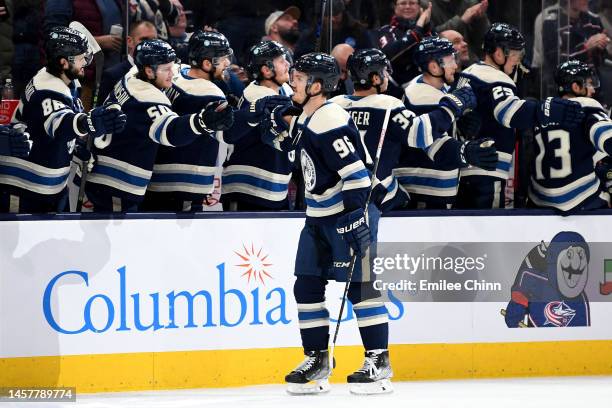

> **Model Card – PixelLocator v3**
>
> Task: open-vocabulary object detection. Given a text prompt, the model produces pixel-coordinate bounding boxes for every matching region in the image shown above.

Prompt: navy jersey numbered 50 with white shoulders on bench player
[86,71,210,203]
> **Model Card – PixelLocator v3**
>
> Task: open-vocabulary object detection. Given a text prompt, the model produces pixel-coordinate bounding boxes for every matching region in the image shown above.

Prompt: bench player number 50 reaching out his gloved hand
[85,40,233,212]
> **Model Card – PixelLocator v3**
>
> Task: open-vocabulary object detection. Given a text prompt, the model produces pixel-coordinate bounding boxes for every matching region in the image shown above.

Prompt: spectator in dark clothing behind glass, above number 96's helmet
[295,0,374,59]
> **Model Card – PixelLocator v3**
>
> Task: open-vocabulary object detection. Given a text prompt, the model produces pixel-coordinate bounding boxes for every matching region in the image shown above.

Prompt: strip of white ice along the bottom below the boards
[11,377,612,408]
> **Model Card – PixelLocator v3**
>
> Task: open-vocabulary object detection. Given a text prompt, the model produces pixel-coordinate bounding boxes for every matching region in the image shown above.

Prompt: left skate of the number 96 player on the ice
[285,350,331,395]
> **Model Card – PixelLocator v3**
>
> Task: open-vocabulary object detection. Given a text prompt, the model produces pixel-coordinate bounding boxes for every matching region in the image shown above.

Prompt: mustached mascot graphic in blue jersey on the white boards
[502,231,591,327]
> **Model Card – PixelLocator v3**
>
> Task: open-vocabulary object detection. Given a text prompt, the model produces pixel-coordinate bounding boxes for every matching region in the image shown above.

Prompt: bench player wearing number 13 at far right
[529,60,612,212]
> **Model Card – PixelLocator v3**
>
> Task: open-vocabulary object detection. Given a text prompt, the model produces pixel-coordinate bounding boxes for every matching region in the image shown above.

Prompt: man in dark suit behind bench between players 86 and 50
[99,20,157,101]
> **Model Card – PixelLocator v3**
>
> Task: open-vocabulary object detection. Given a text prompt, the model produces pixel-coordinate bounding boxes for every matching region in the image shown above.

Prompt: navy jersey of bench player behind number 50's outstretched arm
[148,65,225,201]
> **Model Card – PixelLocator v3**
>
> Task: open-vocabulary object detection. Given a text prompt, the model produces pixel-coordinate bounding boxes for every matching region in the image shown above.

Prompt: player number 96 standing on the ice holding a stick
[262,53,392,394]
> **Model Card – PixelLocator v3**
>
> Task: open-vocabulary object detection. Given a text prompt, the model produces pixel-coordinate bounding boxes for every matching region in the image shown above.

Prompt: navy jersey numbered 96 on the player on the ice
[289,102,370,224]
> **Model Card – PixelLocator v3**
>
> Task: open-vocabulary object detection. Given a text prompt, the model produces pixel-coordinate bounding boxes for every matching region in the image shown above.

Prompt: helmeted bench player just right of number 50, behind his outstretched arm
[143,31,232,212]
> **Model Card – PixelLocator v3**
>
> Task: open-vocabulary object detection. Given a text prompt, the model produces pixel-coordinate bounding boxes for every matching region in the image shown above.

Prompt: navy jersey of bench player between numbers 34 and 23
[402,75,459,204]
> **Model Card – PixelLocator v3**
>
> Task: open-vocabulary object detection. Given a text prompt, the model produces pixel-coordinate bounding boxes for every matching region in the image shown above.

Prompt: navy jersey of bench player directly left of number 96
[221,82,295,209]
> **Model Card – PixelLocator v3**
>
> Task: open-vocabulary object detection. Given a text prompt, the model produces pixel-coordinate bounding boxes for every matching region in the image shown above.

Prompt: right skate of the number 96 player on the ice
[347,350,393,395]
